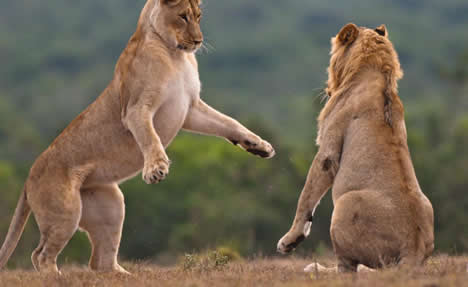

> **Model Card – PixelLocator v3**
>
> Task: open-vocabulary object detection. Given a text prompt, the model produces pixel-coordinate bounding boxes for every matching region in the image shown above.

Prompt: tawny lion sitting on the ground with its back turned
[277,24,434,272]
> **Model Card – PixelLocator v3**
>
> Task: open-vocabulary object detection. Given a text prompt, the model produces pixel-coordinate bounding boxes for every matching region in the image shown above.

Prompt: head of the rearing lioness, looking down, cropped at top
[140,0,203,52]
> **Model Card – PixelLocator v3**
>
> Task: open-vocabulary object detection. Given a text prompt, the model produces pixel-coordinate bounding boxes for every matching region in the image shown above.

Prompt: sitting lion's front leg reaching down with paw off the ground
[277,151,338,254]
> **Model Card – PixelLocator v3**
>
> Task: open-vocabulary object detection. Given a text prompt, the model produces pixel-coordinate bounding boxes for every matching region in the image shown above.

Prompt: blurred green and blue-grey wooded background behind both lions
[0,0,468,267]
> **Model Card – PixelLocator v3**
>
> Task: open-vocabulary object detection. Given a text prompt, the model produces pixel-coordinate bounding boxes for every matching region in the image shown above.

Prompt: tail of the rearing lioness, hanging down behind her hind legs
[0,189,31,269]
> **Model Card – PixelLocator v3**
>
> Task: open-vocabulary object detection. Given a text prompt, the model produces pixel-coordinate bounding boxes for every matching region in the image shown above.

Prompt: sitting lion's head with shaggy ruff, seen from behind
[327,23,403,97]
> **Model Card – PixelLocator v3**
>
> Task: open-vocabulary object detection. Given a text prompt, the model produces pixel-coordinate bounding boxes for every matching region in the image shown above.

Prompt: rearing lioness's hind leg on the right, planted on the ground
[80,184,128,273]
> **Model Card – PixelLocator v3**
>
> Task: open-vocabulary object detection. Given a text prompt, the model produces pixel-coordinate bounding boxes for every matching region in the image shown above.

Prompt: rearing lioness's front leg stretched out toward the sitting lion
[183,100,275,158]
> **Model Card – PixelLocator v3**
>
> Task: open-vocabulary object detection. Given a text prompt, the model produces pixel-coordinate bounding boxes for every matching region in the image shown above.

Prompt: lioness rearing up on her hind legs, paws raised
[0,0,275,272]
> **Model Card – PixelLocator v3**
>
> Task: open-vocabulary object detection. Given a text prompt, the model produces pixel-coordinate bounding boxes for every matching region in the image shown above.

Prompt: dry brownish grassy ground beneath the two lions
[0,256,468,287]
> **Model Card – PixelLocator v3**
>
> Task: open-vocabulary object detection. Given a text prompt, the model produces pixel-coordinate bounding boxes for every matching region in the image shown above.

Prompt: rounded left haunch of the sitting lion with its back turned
[330,190,407,272]
